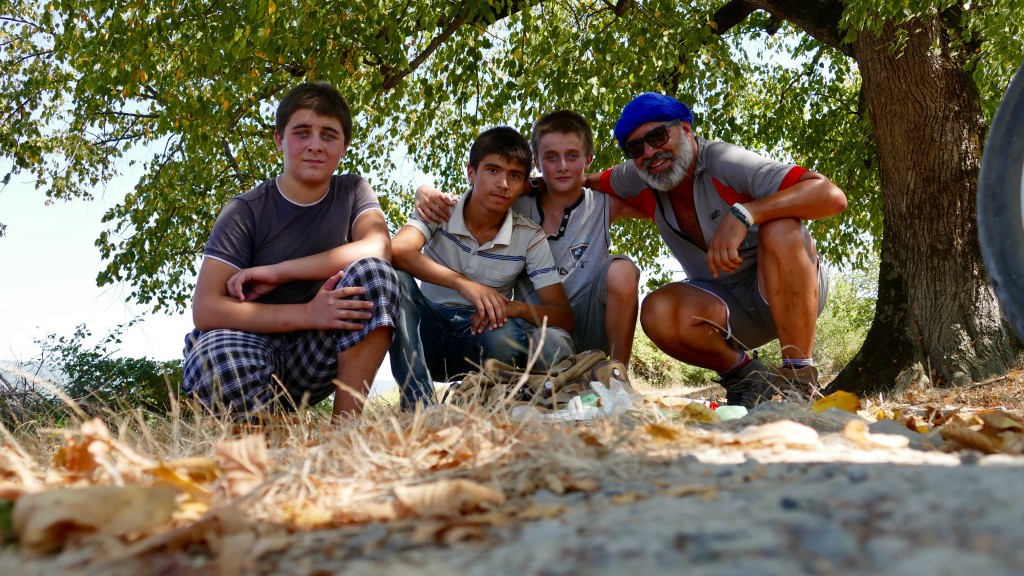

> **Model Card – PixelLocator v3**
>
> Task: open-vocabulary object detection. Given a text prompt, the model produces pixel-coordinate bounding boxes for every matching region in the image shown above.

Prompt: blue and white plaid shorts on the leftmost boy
[182,258,400,413]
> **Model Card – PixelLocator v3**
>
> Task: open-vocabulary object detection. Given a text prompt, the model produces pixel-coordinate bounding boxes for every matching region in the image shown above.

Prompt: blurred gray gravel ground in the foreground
[264,405,1024,576]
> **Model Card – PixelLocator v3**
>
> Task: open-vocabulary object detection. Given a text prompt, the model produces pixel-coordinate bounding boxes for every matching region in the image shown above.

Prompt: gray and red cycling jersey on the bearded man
[601,135,807,284]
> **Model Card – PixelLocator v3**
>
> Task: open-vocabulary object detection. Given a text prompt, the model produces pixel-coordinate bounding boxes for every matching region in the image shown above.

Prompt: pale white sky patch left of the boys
[0,176,191,360]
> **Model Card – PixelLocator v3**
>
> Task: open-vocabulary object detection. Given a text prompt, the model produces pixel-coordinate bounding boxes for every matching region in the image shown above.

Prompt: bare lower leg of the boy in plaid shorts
[333,326,393,421]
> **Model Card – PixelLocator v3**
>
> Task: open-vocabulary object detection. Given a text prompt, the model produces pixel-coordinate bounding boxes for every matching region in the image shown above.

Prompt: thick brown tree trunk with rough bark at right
[830,14,1021,394]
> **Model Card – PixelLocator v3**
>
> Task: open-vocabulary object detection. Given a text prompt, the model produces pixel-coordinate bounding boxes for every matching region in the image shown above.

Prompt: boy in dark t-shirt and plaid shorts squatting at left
[183,82,399,418]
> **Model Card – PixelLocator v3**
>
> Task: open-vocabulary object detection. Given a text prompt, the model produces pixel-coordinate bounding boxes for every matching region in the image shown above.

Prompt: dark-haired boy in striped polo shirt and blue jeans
[390,126,575,409]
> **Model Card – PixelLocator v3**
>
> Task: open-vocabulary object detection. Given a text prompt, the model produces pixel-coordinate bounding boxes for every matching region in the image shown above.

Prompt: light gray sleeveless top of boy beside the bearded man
[512,189,611,302]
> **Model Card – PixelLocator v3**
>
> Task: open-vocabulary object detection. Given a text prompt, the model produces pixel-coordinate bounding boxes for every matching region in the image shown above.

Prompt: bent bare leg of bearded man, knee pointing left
[640,282,739,372]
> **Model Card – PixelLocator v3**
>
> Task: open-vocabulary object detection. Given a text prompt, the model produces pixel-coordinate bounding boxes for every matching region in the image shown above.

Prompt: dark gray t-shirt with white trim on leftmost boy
[205,174,381,303]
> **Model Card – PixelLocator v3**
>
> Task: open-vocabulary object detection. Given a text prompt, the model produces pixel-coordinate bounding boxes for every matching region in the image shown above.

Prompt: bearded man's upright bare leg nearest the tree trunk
[758,218,818,358]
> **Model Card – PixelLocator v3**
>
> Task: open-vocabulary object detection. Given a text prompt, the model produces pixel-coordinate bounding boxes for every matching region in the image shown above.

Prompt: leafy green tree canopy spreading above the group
[0,0,1024,385]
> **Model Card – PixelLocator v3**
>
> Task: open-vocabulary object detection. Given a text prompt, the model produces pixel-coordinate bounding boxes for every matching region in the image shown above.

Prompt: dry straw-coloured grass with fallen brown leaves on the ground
[0,372,1024,573]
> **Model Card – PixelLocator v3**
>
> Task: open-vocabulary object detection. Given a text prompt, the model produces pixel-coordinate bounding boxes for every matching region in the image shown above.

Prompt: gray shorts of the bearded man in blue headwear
[685,258,828,349]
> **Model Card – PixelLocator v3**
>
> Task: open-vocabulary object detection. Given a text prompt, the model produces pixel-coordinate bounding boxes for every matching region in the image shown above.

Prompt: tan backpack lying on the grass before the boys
[441,349,639,412]
